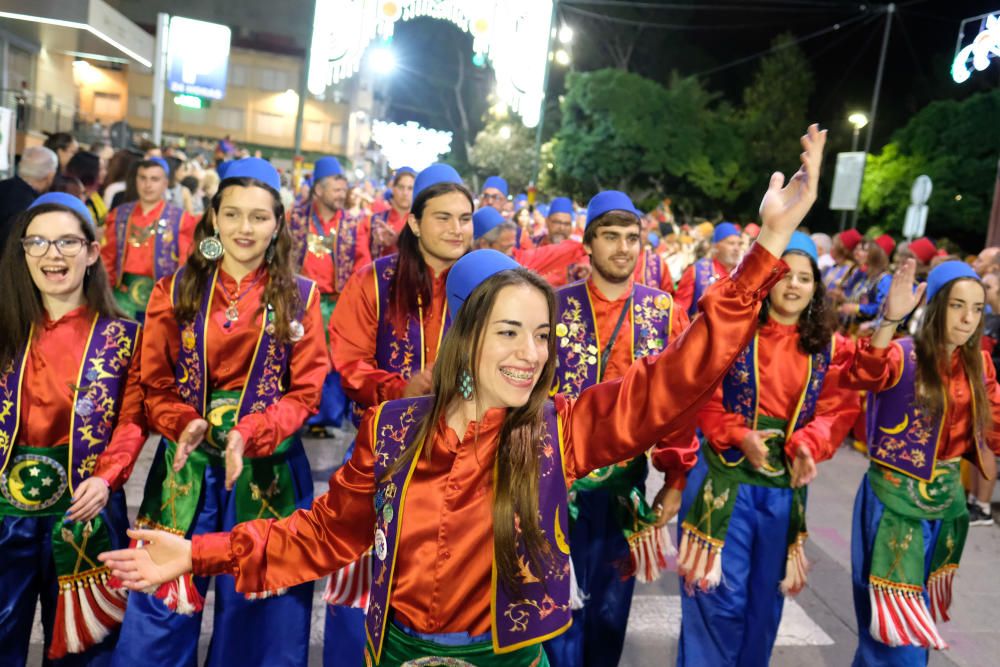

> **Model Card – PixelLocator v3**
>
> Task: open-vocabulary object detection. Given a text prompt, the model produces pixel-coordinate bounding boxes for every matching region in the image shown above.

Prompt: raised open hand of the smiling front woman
[757,124,826,257]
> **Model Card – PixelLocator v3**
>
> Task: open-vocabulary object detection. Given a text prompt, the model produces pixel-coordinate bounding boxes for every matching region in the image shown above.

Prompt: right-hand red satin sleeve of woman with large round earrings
[235,289,330,456]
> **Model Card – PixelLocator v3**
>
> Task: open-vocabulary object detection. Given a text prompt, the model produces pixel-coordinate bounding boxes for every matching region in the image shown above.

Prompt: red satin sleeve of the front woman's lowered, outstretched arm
[191,408,376,593]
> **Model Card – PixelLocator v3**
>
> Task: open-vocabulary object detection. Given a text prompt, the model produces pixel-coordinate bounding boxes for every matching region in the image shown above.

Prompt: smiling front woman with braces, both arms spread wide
[102,126,825,666]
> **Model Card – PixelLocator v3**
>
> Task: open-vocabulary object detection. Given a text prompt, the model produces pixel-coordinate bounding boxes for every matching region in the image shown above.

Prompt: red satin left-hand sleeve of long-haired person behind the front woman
[330,265,407,407]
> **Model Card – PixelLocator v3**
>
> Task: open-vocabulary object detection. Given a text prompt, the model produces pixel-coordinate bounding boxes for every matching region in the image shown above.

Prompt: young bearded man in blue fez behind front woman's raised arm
[546,191,698,667]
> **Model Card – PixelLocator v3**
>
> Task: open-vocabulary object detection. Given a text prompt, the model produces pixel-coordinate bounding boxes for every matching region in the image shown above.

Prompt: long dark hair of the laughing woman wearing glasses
[0,204,122,369]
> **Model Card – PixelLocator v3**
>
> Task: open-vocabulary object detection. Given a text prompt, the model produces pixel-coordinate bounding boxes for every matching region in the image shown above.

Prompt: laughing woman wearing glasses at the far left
[0,193,146,665]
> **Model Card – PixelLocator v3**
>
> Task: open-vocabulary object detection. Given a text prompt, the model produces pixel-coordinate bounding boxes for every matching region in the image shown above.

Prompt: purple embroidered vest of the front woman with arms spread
[365,396,572,661]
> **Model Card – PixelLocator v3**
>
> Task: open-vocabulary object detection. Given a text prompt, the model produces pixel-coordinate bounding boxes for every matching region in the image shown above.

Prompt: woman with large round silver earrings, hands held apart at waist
[114,158,329,667]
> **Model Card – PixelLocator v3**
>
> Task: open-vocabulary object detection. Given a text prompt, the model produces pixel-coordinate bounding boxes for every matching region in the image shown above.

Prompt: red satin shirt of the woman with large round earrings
[142,267,330,456]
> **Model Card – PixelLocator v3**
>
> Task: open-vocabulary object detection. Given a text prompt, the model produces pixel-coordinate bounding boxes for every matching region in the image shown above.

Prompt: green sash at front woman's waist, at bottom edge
[365,623,549,667]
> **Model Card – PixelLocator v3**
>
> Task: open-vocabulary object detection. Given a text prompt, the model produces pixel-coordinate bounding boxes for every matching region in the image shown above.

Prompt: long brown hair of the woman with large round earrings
[174,178,304,343]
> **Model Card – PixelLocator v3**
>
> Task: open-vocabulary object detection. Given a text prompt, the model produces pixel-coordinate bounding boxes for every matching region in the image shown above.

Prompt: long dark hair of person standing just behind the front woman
[389,183,475,328]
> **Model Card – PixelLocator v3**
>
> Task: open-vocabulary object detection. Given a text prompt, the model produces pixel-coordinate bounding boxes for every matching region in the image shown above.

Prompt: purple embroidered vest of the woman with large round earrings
[172,269,315,419]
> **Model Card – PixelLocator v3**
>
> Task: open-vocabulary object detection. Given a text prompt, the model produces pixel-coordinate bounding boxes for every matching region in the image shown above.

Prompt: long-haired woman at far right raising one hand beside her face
[848,259,1000,667]
